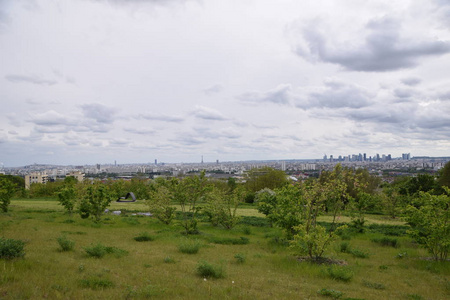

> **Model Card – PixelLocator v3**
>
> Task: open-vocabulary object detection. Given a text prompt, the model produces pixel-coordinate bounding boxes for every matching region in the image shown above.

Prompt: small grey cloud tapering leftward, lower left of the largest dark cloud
[237,84,293,105]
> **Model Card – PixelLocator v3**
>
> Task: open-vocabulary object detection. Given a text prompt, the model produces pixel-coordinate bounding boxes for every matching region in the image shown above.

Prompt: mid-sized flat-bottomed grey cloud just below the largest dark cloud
[296,79,372,109]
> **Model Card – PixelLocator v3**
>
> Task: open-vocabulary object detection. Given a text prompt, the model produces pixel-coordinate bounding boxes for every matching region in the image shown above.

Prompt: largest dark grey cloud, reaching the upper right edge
[294,17,450,72]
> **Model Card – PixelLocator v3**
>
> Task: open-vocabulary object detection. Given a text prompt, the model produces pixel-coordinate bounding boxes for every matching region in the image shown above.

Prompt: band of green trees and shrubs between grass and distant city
[0,163,450,259]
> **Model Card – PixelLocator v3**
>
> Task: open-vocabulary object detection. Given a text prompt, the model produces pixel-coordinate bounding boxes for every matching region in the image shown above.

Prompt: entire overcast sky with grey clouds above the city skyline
[0,0,450,166]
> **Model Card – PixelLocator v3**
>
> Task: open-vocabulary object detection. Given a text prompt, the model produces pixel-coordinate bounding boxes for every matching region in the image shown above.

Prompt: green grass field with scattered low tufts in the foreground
[0,199,450,299]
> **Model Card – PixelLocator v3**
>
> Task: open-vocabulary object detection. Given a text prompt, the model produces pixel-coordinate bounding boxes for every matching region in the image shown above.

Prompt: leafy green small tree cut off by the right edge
[406,186,450,260]
